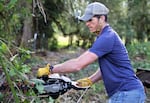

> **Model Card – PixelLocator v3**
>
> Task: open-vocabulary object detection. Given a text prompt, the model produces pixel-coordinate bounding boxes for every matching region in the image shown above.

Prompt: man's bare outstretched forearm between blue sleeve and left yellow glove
[53,51,98,73]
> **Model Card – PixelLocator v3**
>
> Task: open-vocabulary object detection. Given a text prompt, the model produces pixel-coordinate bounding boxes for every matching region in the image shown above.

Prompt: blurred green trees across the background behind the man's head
[0,0,150,49]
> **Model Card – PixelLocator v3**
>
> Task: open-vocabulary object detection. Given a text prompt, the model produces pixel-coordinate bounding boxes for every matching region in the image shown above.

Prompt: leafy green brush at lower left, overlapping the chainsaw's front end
[0,40,54,103]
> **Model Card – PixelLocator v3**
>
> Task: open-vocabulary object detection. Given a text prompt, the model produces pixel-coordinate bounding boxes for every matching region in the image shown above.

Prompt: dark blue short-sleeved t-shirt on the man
[89,25,142,97]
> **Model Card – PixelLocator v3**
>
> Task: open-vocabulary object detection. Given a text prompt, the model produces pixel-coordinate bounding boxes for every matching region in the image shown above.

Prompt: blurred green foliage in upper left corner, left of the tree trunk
[0,0,32,48]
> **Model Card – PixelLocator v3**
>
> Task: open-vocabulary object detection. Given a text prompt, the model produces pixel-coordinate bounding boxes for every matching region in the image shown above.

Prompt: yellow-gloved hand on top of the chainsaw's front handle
[37,64,51,77]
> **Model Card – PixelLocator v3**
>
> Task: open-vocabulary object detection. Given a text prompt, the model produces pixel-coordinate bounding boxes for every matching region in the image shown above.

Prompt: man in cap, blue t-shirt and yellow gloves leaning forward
[38,2,146,103]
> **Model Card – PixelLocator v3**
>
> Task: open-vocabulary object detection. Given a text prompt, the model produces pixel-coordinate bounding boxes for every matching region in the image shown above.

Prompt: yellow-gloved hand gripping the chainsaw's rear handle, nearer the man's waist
[77,77,93,87]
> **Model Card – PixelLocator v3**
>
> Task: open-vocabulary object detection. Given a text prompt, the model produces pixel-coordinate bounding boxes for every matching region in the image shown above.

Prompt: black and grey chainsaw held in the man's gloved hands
[0,74,89,99]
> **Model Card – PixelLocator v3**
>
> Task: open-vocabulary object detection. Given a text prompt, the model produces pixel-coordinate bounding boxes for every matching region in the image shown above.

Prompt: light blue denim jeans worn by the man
[108,89,146,103]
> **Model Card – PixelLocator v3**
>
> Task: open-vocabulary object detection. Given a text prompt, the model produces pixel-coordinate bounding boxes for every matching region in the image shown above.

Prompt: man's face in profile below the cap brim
[86,17,102,33]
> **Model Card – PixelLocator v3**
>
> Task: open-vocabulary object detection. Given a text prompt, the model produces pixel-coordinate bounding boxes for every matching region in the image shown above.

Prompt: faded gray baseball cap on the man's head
[78,2,109,21]
